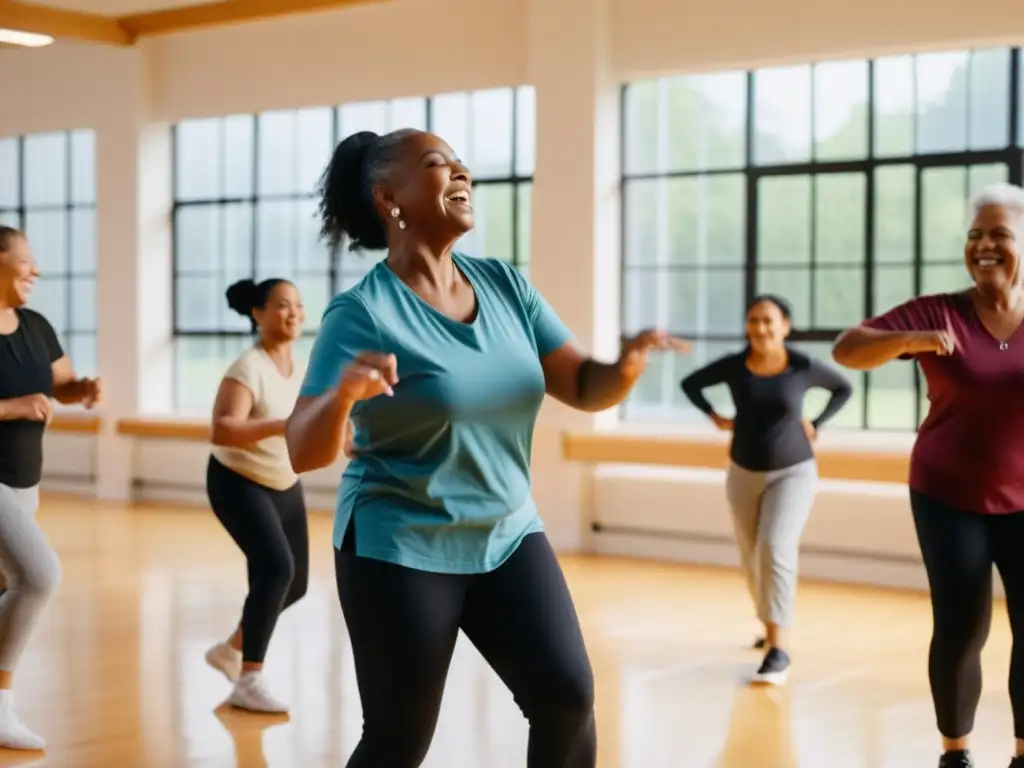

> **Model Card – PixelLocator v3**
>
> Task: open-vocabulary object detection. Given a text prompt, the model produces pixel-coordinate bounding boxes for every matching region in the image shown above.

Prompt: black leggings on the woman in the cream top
[206,456,309,663]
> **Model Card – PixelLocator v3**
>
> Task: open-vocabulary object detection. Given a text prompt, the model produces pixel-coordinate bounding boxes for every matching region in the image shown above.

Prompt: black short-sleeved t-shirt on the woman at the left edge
[0,309,63,488]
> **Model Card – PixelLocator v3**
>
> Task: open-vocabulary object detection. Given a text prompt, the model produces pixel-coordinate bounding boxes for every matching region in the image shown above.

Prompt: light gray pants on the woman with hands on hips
[725,459,818,627]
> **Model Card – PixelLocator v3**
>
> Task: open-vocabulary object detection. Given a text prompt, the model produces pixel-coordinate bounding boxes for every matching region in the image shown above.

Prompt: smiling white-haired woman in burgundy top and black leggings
[833,184,1024,768]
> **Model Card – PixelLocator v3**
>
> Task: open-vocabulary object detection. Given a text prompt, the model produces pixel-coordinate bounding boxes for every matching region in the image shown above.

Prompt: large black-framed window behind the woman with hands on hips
[623,48,1024,430]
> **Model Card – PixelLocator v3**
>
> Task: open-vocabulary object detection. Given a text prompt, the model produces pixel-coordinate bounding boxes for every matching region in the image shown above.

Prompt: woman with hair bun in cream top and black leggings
[206,278,309,714]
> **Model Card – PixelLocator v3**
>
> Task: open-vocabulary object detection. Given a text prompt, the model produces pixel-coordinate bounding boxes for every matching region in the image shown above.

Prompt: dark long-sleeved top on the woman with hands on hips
[682,349,853,472]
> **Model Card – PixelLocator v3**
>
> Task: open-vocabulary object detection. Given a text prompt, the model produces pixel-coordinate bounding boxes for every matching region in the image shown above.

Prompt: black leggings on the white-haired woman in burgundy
[910,490,1024,738]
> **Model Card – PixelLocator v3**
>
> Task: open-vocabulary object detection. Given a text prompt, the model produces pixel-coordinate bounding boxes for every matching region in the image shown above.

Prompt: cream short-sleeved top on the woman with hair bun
[212,344,305,490]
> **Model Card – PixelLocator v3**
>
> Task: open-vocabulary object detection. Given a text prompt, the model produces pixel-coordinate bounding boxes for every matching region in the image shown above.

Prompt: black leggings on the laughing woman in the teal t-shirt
[335,526,597,768]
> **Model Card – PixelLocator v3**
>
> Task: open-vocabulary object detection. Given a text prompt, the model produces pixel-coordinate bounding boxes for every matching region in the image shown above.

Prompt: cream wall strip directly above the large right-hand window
[612,0,1024,78]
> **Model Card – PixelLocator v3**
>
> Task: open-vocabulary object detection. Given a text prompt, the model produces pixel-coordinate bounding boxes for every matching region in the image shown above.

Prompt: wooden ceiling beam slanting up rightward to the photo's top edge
[118,0,382,37]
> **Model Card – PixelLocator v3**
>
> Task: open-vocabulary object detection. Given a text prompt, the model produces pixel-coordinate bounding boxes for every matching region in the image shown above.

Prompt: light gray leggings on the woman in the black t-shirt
[0,483,60,672]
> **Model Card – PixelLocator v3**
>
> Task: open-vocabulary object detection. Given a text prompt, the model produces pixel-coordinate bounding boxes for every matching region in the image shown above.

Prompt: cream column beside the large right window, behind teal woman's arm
[529,0,620,551]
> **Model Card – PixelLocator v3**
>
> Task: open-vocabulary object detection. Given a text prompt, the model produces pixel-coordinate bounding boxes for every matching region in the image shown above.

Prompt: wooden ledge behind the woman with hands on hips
[562,432,910,483]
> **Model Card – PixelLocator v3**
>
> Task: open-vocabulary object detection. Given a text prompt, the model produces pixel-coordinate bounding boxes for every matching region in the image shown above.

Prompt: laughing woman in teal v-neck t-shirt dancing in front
[287,130,684,768]
